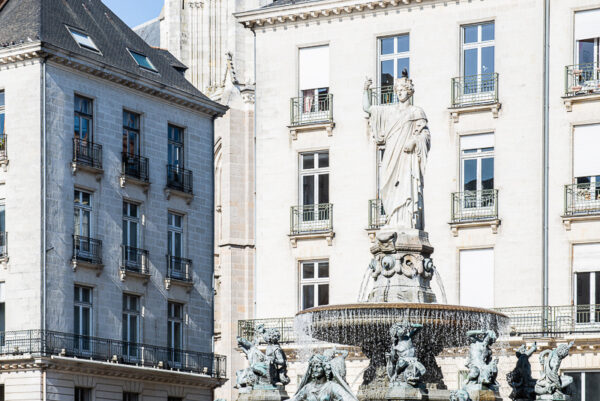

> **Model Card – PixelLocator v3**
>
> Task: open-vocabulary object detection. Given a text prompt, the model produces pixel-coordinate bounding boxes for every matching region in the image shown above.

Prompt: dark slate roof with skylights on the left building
[0,0,208,100]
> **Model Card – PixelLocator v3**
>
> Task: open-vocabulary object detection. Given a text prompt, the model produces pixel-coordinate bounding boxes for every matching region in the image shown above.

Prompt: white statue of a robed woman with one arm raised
[363,72,431,232]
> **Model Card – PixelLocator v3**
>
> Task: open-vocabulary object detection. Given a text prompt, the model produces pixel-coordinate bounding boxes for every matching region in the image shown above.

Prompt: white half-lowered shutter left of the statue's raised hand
[298,46,329,90]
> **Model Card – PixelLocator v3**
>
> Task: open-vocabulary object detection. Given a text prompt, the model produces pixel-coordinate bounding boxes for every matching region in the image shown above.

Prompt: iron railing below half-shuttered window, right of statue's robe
[451,189,498,223]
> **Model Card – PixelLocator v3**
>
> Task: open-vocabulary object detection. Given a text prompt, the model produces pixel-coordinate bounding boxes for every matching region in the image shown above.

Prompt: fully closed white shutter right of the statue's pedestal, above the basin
[460,249,494,308]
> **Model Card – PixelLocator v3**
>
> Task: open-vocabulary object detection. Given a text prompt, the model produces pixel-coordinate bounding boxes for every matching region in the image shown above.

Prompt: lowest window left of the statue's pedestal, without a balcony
[300,260,329,309]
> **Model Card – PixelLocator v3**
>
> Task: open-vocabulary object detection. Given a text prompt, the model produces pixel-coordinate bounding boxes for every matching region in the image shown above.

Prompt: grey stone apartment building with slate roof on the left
[0,0,226,401]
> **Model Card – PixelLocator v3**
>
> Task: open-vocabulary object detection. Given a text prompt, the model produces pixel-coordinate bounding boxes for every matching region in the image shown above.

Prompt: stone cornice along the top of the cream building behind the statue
[234,0,427,29]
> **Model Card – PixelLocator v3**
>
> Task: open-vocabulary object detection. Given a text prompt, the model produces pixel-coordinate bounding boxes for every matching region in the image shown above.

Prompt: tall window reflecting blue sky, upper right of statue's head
[462,22,495,94]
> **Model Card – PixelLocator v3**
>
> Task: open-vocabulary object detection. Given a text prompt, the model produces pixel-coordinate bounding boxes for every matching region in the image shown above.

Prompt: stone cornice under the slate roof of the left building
[0,42,228,118]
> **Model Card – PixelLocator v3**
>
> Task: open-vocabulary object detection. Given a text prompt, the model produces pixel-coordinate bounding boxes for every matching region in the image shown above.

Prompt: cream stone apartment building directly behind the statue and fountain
[236,0,600,401]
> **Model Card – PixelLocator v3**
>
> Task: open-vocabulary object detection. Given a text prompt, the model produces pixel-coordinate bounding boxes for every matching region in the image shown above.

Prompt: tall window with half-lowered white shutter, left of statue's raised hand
[298,45,329,113]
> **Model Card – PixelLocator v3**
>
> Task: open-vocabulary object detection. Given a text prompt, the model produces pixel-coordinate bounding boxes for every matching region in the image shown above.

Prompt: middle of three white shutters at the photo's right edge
[573,124,600,177]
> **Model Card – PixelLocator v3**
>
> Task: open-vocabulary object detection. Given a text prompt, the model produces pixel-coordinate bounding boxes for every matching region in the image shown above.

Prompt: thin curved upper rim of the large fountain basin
[296,302,508,319]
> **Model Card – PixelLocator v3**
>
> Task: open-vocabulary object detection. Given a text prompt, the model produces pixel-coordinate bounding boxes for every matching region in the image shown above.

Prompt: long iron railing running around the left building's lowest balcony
[0,330,227,378]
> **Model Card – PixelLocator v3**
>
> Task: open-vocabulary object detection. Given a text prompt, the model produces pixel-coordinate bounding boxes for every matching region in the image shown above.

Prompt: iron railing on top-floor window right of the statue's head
[451,72,498,107]
